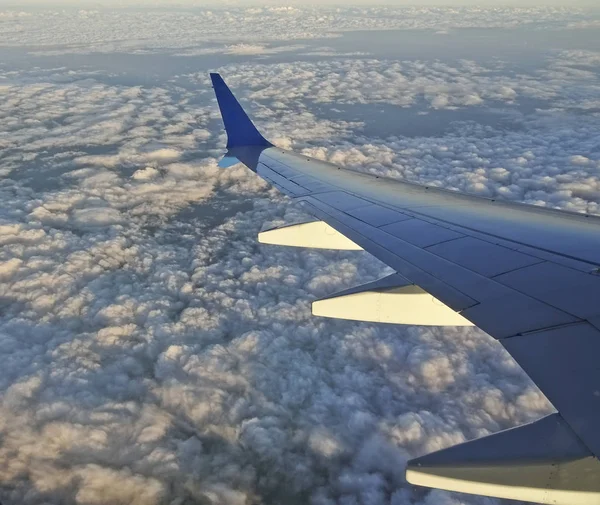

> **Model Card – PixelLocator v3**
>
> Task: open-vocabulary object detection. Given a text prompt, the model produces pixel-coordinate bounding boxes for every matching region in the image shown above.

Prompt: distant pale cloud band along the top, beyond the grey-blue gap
[0,5,595,55]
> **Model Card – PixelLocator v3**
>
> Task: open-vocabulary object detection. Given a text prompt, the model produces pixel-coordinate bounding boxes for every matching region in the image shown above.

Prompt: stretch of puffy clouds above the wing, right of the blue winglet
[190,55,600,213]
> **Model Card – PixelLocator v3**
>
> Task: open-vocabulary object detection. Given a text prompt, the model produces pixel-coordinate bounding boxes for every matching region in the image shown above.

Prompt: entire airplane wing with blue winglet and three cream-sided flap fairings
[211,74,600,505]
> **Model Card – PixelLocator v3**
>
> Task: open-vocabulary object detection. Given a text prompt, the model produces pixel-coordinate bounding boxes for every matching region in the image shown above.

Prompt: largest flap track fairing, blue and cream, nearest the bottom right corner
[406,414,600,505]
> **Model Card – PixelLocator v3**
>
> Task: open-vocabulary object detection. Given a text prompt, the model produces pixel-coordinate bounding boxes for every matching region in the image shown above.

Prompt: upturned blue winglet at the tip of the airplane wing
[210,74,273,149]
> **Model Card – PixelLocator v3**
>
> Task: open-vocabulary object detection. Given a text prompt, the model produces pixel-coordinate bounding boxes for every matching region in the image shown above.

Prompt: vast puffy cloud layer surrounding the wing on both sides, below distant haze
[0,6,600,505]
